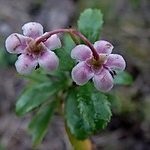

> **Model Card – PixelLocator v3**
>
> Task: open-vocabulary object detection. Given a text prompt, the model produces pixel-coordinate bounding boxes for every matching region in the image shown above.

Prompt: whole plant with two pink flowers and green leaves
[6,9,131,149]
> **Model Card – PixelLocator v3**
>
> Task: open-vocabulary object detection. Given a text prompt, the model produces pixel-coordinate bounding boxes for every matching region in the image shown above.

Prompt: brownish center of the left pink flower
[27,39,44,55]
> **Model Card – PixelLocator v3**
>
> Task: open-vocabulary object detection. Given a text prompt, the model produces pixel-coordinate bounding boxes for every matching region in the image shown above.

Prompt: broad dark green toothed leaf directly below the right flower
[65,86,111,140]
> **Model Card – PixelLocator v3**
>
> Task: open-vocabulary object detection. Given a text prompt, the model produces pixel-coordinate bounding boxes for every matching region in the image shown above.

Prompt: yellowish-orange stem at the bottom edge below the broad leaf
[65,123,92,150]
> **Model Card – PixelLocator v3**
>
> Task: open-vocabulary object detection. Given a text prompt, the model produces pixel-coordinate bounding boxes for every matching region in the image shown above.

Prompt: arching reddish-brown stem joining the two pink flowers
[36,29,99,60]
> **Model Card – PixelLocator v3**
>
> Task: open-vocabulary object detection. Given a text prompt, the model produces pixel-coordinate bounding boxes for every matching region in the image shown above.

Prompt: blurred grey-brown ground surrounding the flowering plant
[0,0,150,150]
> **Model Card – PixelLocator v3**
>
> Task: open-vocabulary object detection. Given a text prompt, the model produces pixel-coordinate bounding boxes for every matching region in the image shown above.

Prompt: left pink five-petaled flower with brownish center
[5,22,61,74]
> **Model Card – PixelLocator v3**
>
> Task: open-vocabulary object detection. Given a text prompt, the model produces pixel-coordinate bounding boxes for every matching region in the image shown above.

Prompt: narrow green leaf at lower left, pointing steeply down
[29,101,57,145]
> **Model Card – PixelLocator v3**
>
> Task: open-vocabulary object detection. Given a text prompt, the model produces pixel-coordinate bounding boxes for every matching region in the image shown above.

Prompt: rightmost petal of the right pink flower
[105,54,126,71]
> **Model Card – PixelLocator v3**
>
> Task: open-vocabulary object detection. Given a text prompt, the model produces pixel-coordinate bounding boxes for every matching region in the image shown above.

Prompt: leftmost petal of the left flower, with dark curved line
[5,33,29,54]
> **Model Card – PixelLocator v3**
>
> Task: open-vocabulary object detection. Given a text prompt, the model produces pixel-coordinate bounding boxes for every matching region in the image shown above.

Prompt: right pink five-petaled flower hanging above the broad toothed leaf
[71,40,126,92]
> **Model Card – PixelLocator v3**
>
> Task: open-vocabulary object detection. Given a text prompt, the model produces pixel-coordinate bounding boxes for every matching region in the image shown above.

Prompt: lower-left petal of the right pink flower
[71,62,94,85]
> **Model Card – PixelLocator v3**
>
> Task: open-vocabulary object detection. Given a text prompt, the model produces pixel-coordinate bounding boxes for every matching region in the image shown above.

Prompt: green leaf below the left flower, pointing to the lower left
[16,82,62,116]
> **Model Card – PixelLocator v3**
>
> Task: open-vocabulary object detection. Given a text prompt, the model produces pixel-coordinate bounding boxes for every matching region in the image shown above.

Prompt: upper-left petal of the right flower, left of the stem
[71,44,92,61]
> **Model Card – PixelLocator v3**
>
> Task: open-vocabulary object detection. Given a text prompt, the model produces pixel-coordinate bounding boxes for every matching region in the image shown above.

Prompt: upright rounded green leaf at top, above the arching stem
[78,9,103,43]
